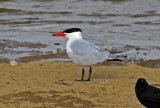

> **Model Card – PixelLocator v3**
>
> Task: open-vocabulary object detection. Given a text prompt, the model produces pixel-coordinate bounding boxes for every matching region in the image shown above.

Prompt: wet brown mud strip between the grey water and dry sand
[0,54,160,68]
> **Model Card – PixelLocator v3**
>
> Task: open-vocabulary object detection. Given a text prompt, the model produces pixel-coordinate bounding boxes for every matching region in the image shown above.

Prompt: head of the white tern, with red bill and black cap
[52,28,82,39]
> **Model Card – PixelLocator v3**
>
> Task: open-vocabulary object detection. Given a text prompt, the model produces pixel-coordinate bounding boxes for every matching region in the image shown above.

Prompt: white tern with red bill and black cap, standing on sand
[52,28,110,81]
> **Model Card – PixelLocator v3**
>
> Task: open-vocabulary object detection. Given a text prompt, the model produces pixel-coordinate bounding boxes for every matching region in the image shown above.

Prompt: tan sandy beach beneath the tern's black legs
[0,61,160,108]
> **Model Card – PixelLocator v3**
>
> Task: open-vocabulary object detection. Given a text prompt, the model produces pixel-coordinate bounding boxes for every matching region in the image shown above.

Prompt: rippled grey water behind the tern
[0,0,160,60]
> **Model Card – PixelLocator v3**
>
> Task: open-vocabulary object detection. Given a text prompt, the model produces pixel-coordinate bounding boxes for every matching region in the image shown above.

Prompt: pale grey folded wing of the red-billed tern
[70,39,109,64]
